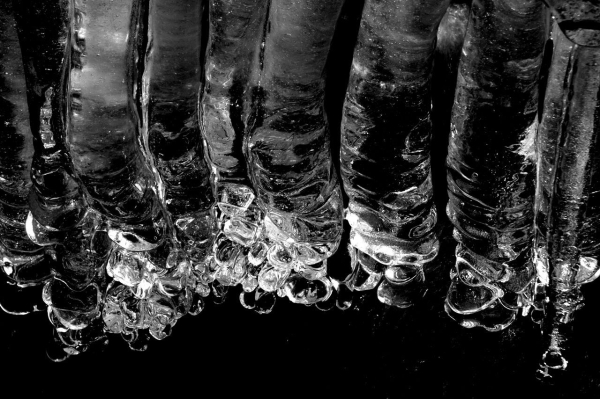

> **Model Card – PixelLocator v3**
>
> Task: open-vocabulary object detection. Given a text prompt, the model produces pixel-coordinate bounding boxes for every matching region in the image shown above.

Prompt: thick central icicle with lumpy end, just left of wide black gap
[244,0,343,304]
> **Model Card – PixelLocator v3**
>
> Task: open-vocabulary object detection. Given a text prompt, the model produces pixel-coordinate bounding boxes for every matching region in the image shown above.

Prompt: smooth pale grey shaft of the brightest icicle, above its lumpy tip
[69,1,164,244]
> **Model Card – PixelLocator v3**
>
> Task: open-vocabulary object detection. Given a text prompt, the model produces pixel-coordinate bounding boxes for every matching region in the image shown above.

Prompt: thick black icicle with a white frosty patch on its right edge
[446,0,548,331]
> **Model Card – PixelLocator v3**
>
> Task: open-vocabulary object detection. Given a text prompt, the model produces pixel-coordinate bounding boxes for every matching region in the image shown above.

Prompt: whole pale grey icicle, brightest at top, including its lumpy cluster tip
[69,0,186,346]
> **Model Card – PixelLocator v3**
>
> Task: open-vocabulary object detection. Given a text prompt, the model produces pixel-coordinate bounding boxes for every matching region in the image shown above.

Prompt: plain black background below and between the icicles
[0,0,600,398]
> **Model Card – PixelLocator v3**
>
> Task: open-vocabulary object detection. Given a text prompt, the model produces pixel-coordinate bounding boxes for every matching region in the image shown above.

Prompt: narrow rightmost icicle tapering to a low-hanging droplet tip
[534,21,600,376]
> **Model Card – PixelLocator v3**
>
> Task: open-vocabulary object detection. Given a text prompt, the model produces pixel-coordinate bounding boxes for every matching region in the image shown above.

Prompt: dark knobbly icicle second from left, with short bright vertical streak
[13,0,110,360]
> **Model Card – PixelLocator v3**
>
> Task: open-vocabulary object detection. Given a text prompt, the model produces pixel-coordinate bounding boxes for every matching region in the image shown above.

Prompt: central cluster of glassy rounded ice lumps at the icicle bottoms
[202,184,340,313]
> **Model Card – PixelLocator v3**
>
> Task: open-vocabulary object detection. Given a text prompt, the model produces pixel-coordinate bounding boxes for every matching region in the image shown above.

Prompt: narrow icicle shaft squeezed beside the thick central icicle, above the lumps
[200,0,270,184]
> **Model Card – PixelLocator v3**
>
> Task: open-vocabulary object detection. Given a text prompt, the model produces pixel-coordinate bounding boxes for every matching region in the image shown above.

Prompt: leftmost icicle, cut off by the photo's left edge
[0,1,55,314]
